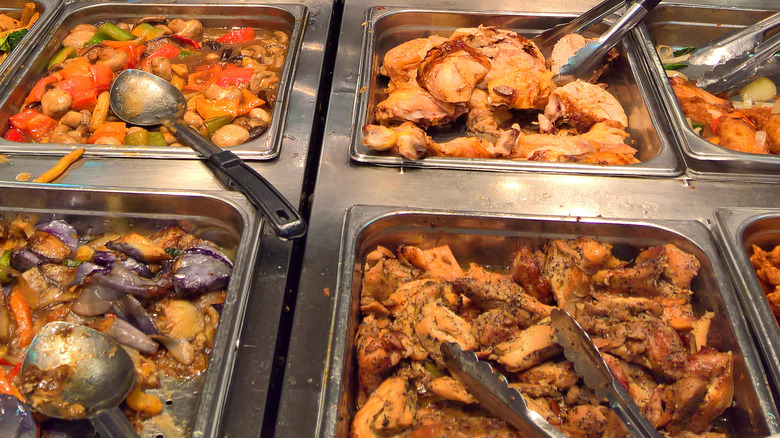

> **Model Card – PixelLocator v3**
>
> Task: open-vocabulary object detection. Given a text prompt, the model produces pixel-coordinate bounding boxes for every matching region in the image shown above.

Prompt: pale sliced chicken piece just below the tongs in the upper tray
[540,80,628,133]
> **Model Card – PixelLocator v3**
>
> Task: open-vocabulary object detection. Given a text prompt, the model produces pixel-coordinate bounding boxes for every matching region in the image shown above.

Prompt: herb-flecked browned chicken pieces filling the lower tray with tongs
[351,237,734,438]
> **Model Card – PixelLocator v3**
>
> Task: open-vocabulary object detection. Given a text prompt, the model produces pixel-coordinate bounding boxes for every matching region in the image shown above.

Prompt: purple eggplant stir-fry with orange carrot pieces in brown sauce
[0,218,233,428]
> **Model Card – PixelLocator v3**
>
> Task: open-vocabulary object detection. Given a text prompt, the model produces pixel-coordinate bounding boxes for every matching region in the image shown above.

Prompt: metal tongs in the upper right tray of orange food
[688,19,780,94]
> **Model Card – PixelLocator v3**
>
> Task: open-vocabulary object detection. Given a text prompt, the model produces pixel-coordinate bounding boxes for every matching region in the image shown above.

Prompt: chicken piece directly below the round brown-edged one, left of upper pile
[375,83,467,128]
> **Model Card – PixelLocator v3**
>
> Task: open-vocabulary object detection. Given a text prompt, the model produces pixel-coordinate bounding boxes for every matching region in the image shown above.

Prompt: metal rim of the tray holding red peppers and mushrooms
[0,0,308,160]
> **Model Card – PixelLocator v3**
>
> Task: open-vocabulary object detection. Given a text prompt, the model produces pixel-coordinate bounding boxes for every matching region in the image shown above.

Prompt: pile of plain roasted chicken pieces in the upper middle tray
[362,26,639,164]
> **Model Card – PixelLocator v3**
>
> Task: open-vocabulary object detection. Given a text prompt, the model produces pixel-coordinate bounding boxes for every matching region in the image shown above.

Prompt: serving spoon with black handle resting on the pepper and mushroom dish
[110,69,306,239]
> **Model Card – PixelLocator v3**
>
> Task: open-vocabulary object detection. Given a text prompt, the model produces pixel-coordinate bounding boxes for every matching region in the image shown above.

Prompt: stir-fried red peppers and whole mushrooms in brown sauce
[5,16,289,147]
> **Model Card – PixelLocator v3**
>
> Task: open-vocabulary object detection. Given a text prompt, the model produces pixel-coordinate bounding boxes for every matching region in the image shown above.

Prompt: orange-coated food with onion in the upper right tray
[656,45,780,154]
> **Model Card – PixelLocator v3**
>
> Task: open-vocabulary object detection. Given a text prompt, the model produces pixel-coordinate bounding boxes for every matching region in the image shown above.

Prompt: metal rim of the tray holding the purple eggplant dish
[0,183,262,437]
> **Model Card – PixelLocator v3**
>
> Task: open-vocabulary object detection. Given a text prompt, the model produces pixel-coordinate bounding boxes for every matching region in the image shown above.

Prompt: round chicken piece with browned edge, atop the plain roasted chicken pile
[417,40,490,103]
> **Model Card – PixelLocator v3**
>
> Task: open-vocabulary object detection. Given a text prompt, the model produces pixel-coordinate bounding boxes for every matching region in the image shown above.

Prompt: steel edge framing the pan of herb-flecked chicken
[315,205,780,438]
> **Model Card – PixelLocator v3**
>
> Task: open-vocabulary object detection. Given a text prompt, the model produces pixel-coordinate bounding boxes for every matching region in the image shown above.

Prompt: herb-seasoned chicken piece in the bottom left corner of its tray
[350,377,417,438]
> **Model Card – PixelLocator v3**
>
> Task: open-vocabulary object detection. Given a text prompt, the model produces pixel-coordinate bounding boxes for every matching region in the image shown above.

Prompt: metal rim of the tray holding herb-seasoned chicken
[315,205,780,438]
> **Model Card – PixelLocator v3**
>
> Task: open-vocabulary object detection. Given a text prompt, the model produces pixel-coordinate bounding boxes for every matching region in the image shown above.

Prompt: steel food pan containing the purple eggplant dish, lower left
[0,184,259,438]
